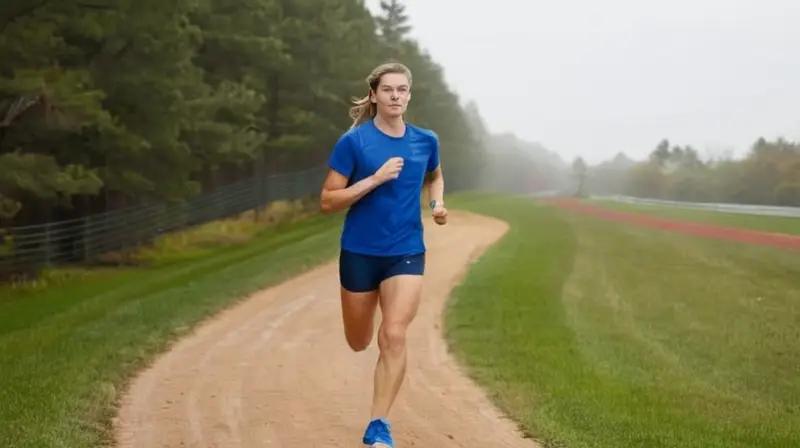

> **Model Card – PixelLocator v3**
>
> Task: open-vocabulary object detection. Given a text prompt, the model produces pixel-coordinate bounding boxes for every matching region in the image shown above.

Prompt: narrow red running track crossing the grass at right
[546,198,800,250]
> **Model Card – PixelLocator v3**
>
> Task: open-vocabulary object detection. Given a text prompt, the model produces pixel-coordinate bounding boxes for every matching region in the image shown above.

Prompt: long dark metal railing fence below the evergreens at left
[0,167,325,278]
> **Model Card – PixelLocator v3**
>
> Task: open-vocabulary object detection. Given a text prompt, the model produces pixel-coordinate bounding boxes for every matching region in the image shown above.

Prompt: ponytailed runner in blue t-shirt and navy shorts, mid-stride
[320,63,447,448]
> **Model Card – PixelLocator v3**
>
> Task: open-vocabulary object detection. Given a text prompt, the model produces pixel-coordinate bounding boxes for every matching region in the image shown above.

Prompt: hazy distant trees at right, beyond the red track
[576,138,800,207]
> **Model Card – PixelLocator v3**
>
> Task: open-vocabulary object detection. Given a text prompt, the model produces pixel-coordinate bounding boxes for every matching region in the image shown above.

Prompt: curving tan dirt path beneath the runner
[116,213,535,448]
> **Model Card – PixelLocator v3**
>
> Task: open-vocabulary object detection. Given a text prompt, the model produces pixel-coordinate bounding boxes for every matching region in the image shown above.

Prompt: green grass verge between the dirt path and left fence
[0,212,341,448]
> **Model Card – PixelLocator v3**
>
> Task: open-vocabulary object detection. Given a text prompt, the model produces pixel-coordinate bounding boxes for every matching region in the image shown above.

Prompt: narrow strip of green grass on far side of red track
[586,199,800,235]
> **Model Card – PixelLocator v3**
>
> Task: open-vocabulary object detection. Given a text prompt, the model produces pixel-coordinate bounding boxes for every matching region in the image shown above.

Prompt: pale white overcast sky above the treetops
[367,0,800,162]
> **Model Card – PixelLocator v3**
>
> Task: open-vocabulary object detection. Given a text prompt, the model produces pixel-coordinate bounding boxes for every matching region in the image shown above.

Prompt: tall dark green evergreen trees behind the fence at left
[0,0,490,228]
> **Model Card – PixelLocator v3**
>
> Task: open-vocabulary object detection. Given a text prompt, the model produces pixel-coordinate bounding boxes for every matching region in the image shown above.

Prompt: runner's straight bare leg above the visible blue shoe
[372,275,422,419]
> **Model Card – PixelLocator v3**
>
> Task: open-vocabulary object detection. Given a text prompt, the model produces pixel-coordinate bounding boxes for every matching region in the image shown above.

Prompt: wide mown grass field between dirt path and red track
[446,194,800,448]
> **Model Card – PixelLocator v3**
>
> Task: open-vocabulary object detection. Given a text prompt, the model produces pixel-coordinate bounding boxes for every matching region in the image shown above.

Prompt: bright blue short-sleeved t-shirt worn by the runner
[328,120,439,256]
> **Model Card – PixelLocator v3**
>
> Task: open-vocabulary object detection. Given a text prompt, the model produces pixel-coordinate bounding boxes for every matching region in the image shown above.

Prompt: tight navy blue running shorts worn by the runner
[339,249,425,292]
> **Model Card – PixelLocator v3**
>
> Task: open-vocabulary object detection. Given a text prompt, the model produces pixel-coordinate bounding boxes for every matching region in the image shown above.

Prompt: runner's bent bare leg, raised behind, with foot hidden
[341,288,378,352]
